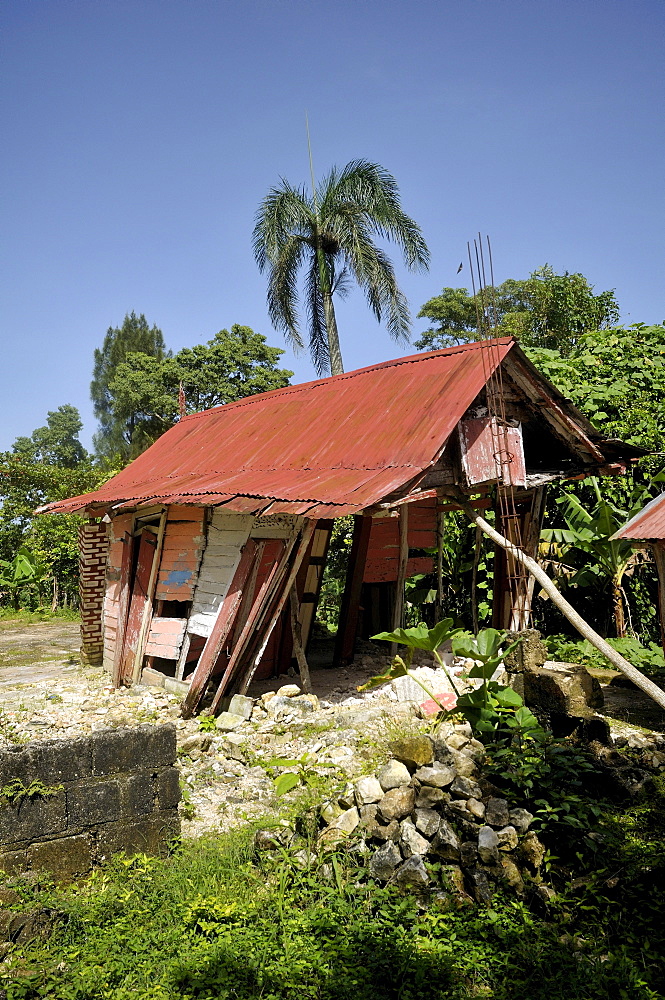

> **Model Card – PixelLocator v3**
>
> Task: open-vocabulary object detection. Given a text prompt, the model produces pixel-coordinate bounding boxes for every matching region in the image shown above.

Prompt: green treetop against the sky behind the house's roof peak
[415,264,619,356]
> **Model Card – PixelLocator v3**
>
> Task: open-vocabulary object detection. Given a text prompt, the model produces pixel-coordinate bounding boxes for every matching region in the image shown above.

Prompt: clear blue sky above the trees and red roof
[0,0,665,448]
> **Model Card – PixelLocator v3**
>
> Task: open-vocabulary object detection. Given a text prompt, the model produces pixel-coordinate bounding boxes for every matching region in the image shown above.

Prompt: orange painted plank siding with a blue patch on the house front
[155,505,205,601]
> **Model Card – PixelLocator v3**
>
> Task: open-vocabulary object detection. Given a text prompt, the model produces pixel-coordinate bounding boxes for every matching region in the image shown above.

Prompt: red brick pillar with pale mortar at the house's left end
[79,522,109,666]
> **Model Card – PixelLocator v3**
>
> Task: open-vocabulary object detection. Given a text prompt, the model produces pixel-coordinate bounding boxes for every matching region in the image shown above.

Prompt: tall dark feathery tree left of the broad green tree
[90,311,167,461]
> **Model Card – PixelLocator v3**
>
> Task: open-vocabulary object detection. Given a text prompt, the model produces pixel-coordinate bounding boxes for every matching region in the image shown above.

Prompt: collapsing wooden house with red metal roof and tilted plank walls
[42,338,641,713]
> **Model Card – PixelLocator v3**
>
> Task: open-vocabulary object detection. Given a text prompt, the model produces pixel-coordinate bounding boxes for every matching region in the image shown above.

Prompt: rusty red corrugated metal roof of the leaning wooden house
[41,338,514,517]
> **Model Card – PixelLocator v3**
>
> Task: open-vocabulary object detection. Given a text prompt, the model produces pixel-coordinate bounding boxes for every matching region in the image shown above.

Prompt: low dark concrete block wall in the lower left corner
[0,724,180,880]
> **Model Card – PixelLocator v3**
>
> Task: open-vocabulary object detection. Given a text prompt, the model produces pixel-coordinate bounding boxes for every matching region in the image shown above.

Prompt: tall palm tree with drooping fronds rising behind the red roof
[253,160,429,375]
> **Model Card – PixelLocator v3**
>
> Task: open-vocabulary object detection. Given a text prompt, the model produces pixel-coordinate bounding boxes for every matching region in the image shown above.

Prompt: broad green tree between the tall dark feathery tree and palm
[109,323,293,446]
